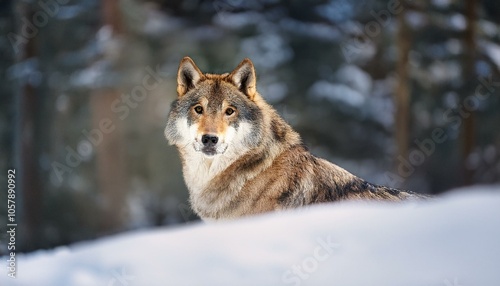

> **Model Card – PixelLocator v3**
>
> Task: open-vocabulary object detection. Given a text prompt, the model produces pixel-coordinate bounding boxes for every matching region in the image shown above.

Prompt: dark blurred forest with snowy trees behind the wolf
[0,0,500,254]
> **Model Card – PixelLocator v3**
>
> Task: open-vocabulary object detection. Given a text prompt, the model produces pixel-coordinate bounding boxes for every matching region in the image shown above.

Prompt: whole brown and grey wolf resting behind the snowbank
[165,57,426,220]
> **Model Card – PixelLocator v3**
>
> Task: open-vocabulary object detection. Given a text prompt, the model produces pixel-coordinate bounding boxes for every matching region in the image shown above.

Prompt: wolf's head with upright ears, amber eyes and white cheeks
[165,57,263,157]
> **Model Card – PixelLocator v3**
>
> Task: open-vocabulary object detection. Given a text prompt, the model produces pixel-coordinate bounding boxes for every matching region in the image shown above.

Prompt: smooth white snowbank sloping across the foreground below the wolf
[0,186,500,286]
